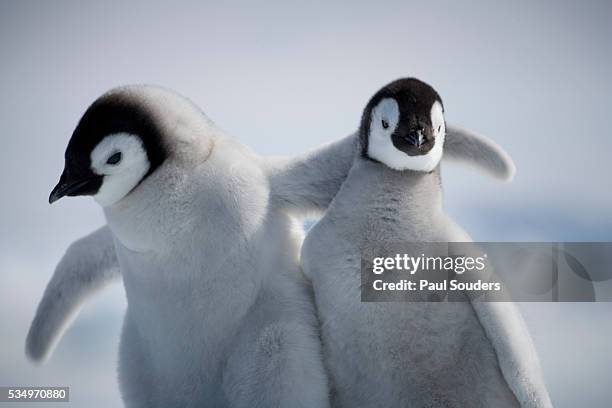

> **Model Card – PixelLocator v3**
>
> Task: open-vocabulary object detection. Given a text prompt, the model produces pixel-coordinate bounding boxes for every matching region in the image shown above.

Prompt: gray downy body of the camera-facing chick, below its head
[302,162,518,407]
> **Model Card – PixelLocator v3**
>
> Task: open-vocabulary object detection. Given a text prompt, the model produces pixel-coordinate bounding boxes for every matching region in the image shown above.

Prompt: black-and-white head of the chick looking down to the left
[49,86,206,206]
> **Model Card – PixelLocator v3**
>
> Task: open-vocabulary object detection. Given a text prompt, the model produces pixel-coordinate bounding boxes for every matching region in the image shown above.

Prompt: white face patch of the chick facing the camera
[368,98,446,172]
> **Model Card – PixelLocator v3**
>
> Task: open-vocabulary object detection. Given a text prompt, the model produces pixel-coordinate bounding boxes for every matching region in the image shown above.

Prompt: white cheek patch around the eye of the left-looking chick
[91,133,151,207]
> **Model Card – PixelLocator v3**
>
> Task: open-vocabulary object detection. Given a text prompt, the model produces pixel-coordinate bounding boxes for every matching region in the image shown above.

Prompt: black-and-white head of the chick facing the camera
[359,78,446,172]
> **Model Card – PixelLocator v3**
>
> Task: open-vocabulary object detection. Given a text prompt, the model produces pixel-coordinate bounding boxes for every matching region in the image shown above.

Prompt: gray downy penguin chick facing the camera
[301,78,551,408]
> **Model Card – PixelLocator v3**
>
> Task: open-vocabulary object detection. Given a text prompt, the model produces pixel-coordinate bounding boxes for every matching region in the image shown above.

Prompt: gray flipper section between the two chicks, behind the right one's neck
[268,133,359,214]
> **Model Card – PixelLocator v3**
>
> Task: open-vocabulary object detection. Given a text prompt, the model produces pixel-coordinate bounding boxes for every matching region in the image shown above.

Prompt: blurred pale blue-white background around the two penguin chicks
[0,0,612,407]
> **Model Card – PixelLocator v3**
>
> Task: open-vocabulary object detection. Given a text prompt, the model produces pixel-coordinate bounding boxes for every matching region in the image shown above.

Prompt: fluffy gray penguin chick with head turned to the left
[39,86,328,407]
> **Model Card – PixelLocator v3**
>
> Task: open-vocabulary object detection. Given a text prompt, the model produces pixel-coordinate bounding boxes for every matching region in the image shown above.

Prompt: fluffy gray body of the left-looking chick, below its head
[112,133,327,406]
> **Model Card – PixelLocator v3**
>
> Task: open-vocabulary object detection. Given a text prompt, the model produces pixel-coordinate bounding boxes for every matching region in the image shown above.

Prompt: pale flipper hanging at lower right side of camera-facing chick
[472,300,552,408]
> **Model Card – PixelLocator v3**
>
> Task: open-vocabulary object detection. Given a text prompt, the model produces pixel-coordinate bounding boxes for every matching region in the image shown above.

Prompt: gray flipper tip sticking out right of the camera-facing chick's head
[443,124,516,181]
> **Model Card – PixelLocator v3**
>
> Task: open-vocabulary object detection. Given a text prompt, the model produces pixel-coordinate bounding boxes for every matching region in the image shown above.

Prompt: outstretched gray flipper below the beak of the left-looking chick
[26,226,120,361]
